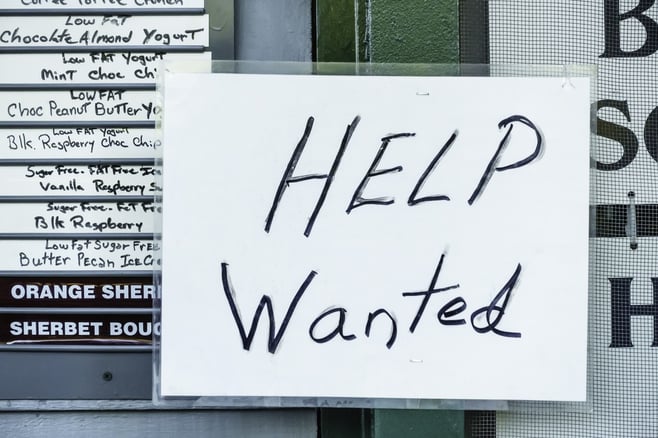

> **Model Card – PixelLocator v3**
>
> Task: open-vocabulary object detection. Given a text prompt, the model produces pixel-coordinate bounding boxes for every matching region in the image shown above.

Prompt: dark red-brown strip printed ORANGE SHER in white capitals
[0,274,154,308]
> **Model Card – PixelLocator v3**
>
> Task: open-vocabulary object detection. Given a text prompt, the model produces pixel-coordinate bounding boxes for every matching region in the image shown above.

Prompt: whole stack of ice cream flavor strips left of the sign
[0,0,211,350]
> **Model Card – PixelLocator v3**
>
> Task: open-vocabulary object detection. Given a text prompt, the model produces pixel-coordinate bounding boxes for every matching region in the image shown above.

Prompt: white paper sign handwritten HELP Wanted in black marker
[161,74,590,401]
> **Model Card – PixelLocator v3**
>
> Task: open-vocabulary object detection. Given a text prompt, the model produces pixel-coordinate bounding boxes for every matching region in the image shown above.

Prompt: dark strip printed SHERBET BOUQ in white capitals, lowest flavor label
[0,313,154,345]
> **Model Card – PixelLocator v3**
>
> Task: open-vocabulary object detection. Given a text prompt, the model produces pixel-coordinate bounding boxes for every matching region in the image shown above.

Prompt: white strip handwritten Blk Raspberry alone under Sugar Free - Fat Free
[0,202,159,234]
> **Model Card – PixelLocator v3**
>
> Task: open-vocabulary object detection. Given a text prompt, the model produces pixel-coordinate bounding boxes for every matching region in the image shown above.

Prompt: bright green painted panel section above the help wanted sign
[365,0,459,63]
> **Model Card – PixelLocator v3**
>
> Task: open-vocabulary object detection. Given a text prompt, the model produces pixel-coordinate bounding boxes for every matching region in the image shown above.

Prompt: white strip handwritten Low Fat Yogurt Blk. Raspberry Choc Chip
[0,128,162,160]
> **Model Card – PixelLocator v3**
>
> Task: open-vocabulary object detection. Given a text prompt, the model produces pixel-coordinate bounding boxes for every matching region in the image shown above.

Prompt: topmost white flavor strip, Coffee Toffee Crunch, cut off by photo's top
[0,0,203,12]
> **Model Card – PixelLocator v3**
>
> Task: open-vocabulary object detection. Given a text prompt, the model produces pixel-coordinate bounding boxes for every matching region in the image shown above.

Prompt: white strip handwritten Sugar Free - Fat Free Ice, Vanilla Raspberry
[0,164,161,196]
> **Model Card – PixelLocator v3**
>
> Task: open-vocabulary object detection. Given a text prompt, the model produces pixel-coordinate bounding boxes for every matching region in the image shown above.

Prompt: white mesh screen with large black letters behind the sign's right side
[460,0,658,438]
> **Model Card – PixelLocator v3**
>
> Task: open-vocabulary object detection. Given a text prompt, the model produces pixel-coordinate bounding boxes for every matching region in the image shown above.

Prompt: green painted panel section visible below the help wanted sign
[372,409,464,438]
